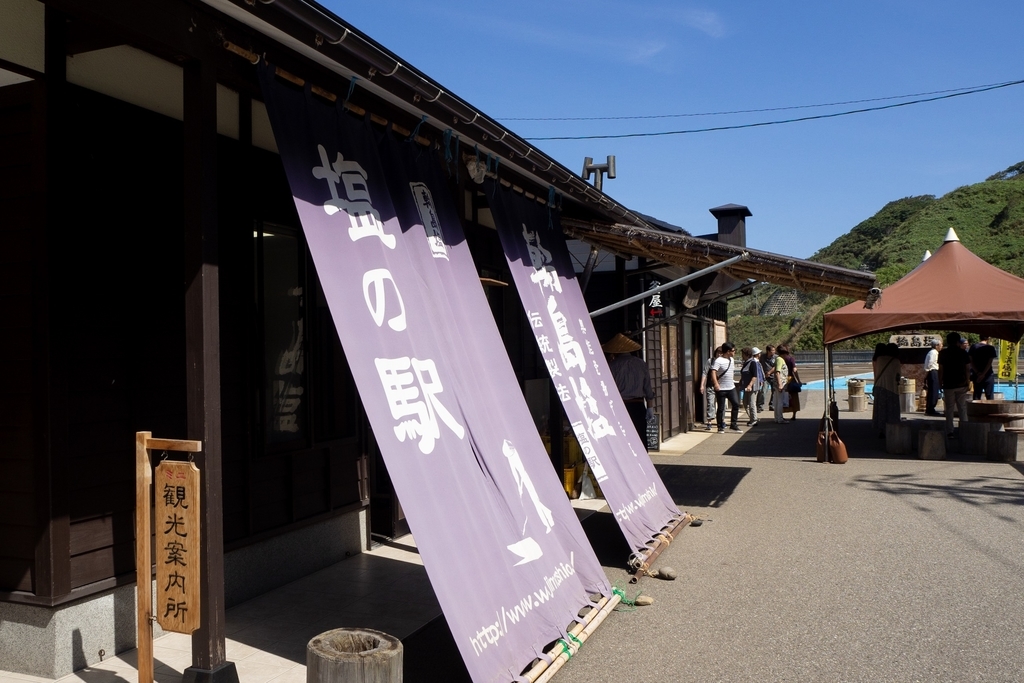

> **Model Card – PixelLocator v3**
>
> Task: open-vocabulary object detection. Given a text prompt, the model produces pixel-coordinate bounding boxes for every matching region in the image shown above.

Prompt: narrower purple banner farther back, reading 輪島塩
[487,180,680,552]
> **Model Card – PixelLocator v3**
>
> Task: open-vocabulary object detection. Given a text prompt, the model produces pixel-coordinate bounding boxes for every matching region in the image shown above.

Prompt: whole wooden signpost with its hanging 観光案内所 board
[135,432,203,683]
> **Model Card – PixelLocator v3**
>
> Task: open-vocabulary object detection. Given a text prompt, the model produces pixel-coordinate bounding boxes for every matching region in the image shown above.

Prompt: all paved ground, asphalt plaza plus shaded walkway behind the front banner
[0,378,1024,683]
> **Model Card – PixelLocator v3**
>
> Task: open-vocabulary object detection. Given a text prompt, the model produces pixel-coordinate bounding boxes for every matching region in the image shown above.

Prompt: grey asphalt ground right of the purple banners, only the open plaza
[555,392,1024,683]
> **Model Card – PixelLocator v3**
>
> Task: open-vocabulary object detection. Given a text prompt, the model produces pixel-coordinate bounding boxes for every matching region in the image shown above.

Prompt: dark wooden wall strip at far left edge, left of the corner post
[0,83,42,591]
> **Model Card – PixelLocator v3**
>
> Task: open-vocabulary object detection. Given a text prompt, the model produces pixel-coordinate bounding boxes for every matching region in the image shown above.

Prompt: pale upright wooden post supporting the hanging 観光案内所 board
[135,432,154,683]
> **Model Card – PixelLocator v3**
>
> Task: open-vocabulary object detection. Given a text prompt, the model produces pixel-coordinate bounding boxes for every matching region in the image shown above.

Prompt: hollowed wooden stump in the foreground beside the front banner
[306,629,402,683]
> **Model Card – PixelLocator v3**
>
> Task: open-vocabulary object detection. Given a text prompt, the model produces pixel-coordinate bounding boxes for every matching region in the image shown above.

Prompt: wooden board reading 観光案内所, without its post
[154,460,201,633]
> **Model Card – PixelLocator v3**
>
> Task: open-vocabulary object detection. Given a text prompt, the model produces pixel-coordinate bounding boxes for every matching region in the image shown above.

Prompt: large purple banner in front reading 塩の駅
[260,67,610,683]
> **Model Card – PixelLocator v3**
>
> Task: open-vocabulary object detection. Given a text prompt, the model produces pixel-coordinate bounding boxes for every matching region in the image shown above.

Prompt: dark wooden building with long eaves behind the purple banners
[0,0,880,678]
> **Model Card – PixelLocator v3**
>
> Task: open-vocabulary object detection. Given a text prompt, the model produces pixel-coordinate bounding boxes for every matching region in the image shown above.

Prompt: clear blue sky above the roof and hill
[325,0,1024,258]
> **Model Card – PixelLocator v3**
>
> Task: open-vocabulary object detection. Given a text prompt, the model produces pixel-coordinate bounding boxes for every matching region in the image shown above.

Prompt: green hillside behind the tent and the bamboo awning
[729,162,1024,350]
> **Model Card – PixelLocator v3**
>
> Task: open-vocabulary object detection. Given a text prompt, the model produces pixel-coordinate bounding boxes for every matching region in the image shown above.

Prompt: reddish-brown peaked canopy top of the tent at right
[824,228,1024,348]
